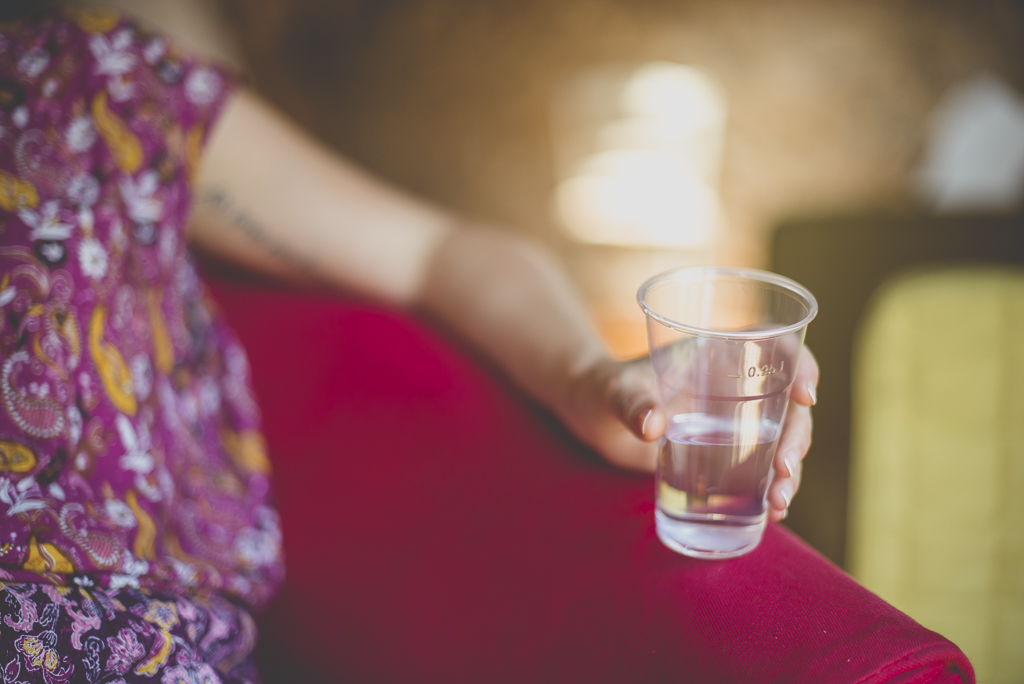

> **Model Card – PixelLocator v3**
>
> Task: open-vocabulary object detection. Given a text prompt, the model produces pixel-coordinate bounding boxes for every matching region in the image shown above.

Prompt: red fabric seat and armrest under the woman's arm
[201,274,974,684]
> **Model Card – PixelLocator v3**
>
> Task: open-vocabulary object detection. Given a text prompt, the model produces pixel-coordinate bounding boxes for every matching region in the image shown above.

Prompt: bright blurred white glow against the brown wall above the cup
[555,61,726,248]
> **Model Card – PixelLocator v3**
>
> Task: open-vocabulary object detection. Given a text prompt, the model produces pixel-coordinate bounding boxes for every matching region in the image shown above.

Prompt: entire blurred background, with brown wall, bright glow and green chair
[144,0,1024,682]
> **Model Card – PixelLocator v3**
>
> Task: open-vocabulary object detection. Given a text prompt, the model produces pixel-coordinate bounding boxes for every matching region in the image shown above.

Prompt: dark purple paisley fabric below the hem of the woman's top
[0,576,259,684]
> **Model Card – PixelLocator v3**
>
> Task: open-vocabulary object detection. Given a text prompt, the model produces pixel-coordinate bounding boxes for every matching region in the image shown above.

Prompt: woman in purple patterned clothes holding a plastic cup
[0,3,817,683]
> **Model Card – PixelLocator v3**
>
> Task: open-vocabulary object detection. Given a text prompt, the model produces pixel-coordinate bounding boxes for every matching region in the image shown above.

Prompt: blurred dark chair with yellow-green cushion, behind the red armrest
[772,217,1024,682]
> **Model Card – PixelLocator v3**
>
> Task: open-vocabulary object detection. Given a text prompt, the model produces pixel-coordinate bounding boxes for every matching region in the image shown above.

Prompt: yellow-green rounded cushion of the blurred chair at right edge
[847,266,1024,684]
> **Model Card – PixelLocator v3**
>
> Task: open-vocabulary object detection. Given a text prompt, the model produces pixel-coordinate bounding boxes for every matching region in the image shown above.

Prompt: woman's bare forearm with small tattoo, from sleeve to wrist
[189,90,451,304]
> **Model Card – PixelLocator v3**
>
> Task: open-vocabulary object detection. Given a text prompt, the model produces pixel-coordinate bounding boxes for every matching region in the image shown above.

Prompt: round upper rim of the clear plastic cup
[637,266,818,340]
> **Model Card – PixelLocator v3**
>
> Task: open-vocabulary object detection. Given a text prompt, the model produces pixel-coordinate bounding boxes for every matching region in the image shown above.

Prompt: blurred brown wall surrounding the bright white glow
[223,0,1024,355]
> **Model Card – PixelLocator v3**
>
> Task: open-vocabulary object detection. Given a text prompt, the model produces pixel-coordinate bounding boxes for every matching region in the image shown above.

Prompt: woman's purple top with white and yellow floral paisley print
[0,10,284,606]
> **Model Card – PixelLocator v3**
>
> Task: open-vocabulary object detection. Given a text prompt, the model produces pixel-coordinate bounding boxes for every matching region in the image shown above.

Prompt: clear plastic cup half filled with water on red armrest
[637,267,818,558]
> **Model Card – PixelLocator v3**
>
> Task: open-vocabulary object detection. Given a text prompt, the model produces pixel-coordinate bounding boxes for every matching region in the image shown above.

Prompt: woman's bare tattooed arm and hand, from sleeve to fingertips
[190,91,817,519]
